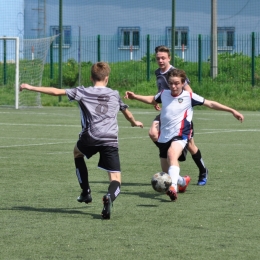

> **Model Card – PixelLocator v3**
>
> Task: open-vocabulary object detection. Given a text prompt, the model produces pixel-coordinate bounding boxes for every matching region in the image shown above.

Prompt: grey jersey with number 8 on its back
[66,87,128,147]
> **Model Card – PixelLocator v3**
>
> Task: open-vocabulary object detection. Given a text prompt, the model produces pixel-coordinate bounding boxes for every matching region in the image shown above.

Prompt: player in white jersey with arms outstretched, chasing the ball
[125,69,244,201]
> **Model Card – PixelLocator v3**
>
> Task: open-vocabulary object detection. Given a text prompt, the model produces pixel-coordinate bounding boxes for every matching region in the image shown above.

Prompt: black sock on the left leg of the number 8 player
[74,157,90,194]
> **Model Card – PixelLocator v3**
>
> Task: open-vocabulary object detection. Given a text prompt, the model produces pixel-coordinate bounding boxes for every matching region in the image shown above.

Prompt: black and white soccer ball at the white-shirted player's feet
[151,172,172,192]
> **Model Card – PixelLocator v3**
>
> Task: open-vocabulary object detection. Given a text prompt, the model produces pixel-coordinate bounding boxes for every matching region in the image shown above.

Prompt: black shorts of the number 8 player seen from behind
[77,140,121,172]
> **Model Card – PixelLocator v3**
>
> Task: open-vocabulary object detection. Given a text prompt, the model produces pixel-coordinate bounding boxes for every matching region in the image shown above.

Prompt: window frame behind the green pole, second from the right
[166,26,189,50]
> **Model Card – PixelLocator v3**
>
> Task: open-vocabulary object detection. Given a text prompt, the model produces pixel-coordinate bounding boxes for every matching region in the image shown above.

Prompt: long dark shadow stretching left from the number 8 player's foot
[6,206,101,219]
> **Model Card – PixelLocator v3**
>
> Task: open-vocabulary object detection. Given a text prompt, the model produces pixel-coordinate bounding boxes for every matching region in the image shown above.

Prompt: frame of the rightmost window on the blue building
[217,27,235,51]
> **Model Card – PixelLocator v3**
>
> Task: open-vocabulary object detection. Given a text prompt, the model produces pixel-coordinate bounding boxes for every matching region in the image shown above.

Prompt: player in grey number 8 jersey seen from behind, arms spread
[20,62,143,219]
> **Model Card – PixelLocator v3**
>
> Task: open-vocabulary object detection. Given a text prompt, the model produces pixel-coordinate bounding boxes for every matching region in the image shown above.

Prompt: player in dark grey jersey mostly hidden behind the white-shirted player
[149,46,208,187]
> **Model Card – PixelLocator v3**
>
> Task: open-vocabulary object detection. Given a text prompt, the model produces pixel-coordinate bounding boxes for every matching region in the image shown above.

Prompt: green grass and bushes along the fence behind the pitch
[0,52,260,110]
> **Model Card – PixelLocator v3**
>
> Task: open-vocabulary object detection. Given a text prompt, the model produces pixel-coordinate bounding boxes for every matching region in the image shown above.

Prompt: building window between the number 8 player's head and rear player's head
[118,27,140,49]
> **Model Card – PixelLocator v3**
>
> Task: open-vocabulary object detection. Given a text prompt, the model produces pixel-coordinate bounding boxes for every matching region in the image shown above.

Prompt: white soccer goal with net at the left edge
[0,36,56,109]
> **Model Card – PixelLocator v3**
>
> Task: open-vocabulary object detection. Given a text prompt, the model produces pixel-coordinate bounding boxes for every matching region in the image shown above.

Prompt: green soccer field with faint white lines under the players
[0,107,260,260]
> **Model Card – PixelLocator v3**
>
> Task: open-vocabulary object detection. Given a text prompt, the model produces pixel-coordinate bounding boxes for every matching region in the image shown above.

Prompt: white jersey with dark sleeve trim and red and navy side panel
[154,90,204,143]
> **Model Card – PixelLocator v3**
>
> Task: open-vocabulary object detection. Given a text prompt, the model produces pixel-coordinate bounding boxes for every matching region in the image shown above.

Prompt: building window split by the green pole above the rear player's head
[166,27,189,49]
